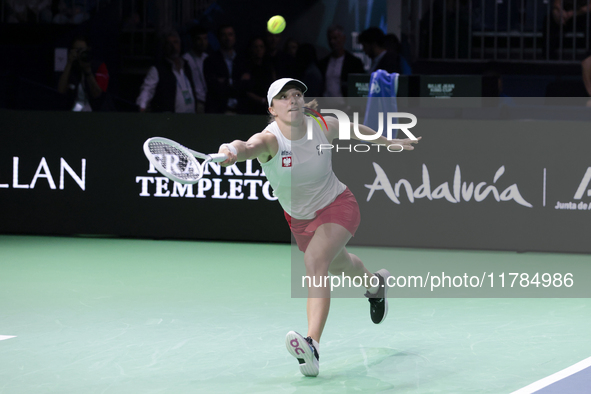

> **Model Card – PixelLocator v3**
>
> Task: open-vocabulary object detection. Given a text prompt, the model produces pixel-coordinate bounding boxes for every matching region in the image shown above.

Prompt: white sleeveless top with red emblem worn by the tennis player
[261,118,347,219]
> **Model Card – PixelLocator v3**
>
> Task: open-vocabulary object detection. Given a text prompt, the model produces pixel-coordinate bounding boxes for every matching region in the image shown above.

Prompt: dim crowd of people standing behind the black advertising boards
[58,25,411,114]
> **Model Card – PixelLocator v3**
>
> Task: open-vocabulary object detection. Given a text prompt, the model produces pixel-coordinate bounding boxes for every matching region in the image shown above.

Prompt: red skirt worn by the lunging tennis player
[283,188,361,252]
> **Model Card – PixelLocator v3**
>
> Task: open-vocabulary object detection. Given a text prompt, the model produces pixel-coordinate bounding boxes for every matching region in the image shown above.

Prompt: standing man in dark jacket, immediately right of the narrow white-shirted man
[203,25,244,114]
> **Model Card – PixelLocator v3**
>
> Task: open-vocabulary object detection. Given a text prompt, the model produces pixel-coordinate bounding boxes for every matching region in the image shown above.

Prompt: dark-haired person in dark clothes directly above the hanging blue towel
[357,27,402,74]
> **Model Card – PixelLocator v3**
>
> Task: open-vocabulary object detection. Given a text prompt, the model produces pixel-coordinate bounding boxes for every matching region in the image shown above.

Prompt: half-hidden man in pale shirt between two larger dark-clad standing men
[183,26,209,114]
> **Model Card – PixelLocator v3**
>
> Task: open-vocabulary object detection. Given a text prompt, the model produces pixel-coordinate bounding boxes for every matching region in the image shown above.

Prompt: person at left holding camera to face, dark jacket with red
[57,36,109,112]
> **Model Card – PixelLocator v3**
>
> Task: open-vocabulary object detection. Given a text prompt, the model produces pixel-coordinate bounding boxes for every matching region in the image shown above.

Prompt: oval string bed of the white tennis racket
[149,141,201,181]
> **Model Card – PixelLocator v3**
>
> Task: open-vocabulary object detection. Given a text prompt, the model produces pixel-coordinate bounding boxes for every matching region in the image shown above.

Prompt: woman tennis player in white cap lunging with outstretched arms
[219,78,418,376]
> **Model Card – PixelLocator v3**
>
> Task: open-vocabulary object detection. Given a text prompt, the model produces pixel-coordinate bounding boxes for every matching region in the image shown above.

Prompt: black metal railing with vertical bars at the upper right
[403,0,591,63]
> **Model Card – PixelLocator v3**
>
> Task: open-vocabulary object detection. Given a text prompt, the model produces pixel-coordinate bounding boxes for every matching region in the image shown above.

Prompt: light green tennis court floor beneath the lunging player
[0,236,591,394]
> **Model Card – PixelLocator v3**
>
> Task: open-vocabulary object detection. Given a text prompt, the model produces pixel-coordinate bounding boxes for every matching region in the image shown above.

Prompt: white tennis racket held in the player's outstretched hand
[144,137,227,184]
